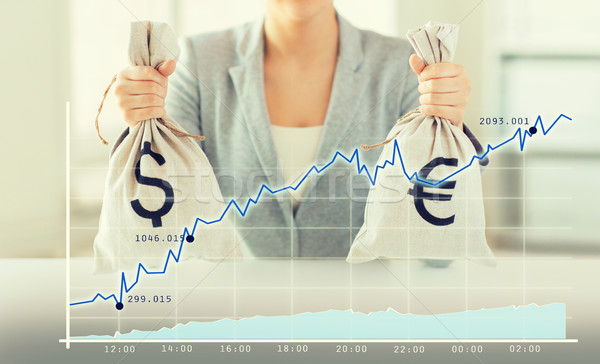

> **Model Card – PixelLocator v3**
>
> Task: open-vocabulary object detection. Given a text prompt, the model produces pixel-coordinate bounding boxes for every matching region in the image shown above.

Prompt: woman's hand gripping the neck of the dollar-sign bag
[113,60,175,127]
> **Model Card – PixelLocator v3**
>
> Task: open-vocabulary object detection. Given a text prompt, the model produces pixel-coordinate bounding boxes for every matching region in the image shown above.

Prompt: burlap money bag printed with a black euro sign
[347,22,494,264]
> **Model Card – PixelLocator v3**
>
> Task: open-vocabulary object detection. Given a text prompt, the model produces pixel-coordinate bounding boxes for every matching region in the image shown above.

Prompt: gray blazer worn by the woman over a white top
[161,15,488,257]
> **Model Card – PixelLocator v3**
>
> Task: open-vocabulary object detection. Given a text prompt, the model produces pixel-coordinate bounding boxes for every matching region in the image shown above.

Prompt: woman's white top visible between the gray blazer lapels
[271,124,323,212]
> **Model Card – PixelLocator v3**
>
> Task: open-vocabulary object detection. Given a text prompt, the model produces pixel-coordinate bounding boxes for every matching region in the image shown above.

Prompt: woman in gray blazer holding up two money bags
[115,0,474,257]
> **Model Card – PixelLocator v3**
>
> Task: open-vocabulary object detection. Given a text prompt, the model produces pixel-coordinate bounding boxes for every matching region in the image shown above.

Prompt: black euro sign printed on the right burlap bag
[408,157,458,226]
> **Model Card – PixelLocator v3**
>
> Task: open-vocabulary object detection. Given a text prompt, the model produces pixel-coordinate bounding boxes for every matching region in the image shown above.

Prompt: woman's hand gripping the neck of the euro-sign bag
[408,54,471,129]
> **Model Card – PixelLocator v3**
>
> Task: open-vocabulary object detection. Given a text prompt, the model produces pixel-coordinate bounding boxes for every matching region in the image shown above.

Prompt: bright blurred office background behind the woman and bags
[0,0,600,257]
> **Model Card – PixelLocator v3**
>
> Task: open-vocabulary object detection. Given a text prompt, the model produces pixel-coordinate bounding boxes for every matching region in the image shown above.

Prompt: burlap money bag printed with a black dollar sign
[94,22,239,272]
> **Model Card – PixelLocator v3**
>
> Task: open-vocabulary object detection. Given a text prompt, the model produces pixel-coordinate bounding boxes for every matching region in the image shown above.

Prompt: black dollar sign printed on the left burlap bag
[131,142,175,227]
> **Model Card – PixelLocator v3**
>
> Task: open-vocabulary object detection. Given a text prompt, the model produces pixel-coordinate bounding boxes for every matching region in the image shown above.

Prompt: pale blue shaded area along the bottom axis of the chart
[73,303,566,340]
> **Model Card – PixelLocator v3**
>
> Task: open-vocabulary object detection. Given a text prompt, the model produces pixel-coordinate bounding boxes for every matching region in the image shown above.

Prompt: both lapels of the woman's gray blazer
[229,14,369,221]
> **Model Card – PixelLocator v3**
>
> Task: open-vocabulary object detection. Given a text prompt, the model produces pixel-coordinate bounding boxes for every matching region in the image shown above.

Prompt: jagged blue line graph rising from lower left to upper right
[70,114,572,309]
